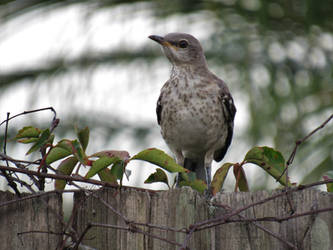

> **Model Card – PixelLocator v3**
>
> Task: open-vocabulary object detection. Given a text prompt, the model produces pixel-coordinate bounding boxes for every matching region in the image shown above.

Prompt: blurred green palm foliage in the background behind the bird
[0,0,333,188]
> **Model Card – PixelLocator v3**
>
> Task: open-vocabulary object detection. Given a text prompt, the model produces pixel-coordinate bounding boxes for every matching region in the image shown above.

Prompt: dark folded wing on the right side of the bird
[214,79,236,161]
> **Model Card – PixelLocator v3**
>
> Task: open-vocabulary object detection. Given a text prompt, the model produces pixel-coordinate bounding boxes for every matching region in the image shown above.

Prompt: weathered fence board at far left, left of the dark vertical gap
[0,191,63,250]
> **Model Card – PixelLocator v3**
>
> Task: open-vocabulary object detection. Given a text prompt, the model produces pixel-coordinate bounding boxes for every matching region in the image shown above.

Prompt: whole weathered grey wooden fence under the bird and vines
[0,188,333,250]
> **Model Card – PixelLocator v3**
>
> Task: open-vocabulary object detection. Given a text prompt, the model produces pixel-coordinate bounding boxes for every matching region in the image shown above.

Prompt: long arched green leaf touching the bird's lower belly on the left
[130,148,187,173]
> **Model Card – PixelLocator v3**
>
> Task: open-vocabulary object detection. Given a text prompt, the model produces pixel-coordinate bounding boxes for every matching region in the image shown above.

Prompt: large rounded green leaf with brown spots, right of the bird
[244,147,291,186]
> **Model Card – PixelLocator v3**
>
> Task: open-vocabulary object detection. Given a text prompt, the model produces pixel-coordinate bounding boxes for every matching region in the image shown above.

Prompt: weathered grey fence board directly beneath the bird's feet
[148,188,211,250]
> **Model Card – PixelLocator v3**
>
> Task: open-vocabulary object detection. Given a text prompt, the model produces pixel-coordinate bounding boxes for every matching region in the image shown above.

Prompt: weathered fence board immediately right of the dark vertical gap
[74,188,150,250]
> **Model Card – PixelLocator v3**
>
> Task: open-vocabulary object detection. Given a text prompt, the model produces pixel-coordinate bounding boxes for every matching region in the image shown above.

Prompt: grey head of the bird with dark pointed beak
[149,33,206,65]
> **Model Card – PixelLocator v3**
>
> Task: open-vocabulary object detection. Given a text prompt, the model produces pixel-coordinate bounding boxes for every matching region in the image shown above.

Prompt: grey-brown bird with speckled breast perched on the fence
[149,32,236,189]
